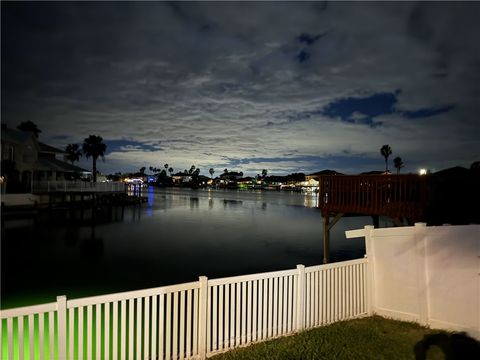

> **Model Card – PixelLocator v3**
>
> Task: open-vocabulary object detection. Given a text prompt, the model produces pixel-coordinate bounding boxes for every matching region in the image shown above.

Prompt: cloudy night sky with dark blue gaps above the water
[1,1,480,175]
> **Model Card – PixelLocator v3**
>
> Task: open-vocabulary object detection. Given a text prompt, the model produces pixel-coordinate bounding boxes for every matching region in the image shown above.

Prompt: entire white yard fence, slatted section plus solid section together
[0,223,480,359]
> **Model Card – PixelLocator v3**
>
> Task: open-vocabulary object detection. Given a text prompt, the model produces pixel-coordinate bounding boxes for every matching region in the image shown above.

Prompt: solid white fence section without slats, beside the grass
[347,224,480,340]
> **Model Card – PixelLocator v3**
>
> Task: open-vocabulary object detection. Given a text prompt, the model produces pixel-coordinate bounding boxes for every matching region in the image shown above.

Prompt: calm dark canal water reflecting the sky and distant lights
[1,188,371,308]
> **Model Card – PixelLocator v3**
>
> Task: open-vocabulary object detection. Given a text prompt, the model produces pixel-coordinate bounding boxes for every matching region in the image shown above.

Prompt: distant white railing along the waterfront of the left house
[32,181,127,193]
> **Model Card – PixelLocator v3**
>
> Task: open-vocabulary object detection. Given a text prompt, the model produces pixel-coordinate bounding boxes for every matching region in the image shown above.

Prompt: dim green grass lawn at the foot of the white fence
[211,316,480,360]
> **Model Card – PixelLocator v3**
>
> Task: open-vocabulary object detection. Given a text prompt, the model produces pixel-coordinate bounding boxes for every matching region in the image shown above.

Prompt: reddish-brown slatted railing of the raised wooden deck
[319,175,427,221]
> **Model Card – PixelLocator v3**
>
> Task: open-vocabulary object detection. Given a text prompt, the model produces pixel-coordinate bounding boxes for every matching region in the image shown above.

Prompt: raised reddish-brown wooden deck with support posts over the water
[318,172,480,263]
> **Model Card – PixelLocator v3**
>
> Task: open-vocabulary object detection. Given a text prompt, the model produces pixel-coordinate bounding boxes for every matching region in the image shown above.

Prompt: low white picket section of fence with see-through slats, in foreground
[0,258,369,360]
